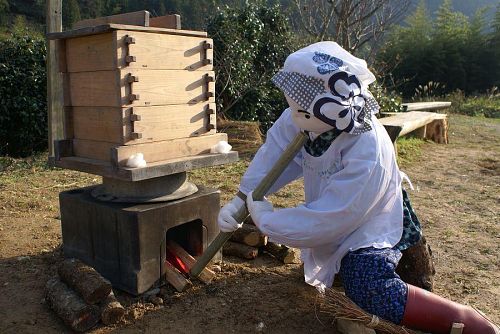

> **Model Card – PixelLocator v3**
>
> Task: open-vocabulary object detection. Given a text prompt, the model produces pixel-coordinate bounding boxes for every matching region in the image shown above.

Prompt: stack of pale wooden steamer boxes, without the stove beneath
[50,13,238,181]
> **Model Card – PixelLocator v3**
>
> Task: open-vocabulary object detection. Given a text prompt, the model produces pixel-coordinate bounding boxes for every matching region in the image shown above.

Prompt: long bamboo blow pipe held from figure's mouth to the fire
[189,132,308,277]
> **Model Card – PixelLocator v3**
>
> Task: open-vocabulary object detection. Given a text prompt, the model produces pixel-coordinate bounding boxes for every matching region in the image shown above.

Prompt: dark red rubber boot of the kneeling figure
[401,284,500,334]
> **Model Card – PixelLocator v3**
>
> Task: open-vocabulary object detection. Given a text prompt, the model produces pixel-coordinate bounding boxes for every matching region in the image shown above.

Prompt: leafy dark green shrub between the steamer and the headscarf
[207,1,293,126]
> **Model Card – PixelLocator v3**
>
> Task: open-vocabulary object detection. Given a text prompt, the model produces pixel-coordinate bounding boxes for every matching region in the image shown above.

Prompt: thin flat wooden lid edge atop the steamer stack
[47,23,207,40]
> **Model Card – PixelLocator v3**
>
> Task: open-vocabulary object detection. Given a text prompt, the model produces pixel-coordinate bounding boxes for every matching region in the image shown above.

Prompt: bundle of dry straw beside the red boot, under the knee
[320,289,415,334]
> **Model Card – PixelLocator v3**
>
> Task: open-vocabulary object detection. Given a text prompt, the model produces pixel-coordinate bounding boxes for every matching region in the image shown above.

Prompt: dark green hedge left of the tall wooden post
[0,30,47,156]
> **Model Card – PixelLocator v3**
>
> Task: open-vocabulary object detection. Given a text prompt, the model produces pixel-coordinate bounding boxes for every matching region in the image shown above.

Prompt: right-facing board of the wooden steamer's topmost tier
[116,30,213,71]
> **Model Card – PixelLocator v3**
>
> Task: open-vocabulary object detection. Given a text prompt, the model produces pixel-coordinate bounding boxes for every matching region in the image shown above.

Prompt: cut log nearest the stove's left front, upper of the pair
[57,259,111,304]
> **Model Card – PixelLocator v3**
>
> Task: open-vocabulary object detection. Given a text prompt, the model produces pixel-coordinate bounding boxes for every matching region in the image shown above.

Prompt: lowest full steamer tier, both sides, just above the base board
[68,103,216,145]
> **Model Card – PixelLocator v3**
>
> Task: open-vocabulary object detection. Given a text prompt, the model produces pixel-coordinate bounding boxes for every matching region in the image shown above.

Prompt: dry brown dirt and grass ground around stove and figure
[0,115,500,333]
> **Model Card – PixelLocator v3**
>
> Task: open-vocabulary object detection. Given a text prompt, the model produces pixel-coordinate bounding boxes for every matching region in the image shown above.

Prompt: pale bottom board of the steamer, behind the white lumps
[113,133,227,166]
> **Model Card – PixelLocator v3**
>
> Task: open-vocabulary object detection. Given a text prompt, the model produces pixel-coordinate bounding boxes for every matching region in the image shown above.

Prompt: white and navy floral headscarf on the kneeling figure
[272,42,379,135]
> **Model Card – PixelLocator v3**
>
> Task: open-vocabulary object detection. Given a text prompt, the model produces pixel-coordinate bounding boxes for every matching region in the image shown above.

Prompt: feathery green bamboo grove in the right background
[377,0,500,98]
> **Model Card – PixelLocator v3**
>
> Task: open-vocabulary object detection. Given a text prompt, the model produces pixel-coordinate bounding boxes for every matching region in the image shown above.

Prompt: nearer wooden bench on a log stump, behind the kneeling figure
[380,111,448,144]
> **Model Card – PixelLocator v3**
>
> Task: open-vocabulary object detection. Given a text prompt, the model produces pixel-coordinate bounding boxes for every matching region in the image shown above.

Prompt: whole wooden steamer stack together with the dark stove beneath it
[48,11,238,294]
